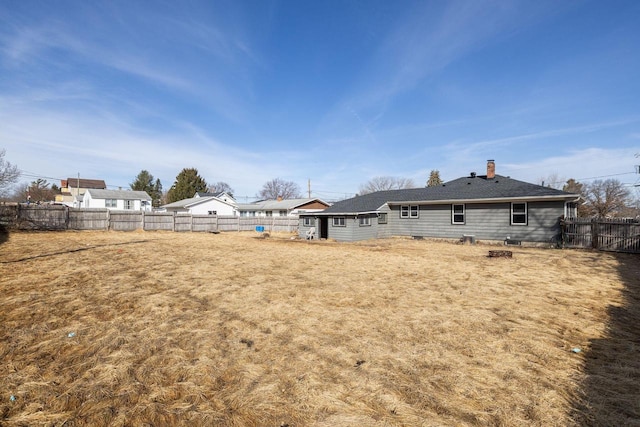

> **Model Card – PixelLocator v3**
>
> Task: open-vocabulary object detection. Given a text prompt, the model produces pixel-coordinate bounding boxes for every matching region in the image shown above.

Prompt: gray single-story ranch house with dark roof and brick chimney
[299,160,580,243]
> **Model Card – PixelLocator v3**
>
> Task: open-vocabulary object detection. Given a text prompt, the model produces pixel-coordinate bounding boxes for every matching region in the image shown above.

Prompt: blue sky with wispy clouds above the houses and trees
[0,0,640,200]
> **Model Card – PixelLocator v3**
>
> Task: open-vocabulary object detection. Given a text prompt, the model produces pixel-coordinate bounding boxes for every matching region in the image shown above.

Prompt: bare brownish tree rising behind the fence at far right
[584,179,631,218]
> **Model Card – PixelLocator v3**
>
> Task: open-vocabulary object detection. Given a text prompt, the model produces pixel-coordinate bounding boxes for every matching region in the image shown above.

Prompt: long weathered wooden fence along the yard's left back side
[0,204,298,232]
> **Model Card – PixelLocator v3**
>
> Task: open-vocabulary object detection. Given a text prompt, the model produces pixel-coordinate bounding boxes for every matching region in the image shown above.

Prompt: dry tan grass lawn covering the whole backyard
[0,232,640,426]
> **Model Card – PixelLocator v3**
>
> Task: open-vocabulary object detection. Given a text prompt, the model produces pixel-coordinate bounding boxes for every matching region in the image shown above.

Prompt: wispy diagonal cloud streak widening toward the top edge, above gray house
[320,1,544,147]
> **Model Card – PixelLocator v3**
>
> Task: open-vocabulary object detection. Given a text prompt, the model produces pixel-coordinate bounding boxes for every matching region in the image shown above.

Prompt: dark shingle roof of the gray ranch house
[322,175,578,214]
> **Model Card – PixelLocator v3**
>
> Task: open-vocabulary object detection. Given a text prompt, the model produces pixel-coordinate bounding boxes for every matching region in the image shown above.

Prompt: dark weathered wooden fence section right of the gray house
[562,218,640,253]
